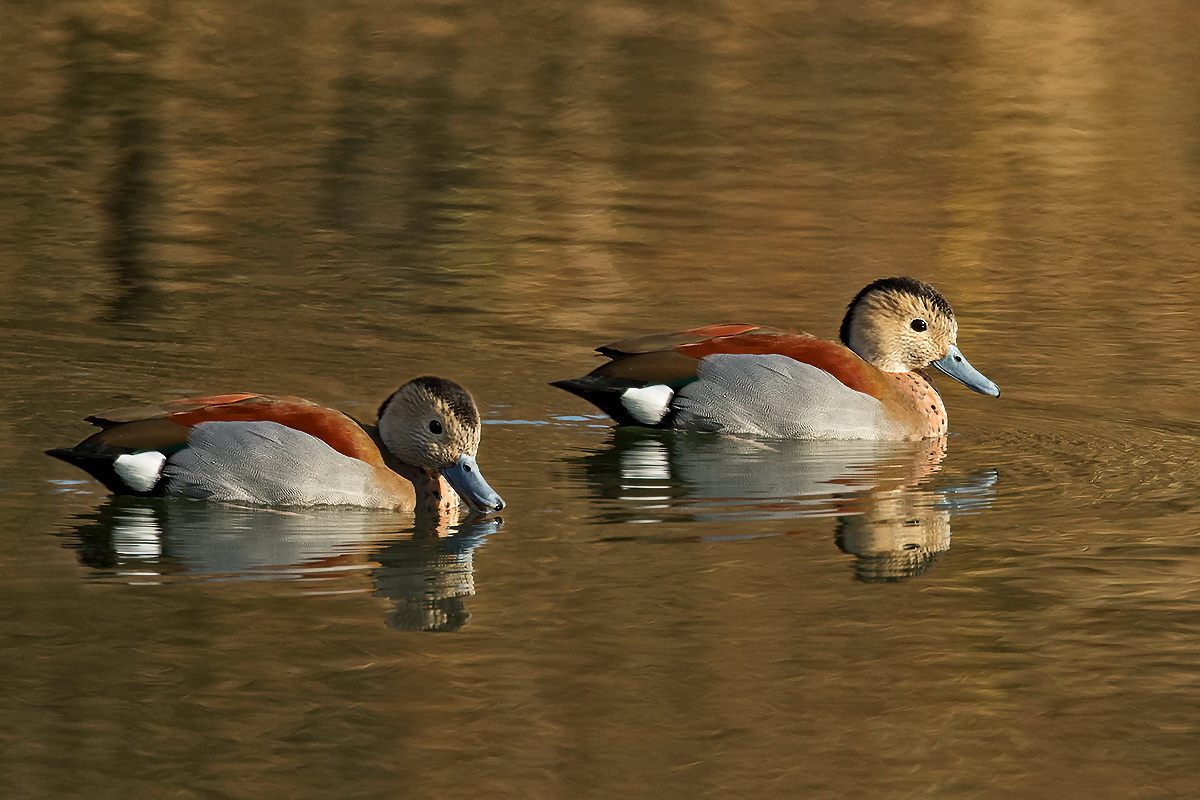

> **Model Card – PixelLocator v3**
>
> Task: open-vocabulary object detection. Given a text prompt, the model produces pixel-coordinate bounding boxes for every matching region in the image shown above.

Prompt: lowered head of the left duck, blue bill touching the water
[379,377,504,512]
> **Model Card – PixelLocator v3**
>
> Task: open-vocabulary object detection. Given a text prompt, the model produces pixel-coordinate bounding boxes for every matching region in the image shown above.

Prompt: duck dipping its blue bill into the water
[46,375,504,516]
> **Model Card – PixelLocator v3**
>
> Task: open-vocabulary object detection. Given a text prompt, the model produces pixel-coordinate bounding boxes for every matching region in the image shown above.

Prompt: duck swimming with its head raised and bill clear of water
[551,277,1000,441]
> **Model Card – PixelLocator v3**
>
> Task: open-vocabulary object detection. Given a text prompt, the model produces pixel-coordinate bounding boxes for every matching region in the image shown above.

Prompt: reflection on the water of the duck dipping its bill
[55,497,503,631]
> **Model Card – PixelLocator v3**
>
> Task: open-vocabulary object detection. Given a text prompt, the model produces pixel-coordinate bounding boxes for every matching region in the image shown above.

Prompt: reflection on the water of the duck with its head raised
[577,429,997,582]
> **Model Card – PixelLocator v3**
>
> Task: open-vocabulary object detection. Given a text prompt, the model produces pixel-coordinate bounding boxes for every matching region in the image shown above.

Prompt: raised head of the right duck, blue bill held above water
[841,278,1000,397]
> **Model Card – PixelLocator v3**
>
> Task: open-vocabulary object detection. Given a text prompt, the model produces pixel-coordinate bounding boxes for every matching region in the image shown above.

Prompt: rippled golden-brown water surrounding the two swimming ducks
[0,0,1200,799]
